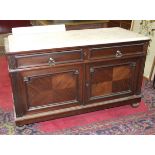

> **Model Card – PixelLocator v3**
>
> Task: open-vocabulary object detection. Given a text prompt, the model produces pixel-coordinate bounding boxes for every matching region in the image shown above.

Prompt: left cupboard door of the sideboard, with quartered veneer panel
[17,65,82,114]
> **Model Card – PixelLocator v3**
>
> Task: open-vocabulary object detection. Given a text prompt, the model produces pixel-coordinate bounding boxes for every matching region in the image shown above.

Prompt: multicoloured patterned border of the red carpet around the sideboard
[0,78,155,135]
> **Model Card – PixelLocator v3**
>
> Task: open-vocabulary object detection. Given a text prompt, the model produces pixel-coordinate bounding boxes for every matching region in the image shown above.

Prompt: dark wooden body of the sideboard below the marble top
[7,41,148,125]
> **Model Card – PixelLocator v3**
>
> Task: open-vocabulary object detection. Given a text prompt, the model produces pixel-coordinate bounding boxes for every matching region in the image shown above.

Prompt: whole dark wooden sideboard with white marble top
[5,28,150,126]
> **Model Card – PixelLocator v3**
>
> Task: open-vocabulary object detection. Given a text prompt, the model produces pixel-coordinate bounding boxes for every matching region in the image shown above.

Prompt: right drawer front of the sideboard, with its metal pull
[89,44,143,59]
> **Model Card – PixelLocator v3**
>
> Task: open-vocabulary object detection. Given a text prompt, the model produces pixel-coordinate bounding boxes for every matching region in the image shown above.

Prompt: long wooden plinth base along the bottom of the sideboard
[16,96,141,126]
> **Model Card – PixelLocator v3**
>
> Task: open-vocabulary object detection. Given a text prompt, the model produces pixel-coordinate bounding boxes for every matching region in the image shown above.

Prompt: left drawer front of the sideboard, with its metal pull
[15,50,83,68]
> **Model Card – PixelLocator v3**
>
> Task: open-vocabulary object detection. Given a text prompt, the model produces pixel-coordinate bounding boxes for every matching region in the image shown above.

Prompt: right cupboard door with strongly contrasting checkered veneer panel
[86,60,136,102]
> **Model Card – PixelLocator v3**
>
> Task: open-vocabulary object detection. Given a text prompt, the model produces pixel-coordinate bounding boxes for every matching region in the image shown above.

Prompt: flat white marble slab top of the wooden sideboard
[5,27,150,53]
